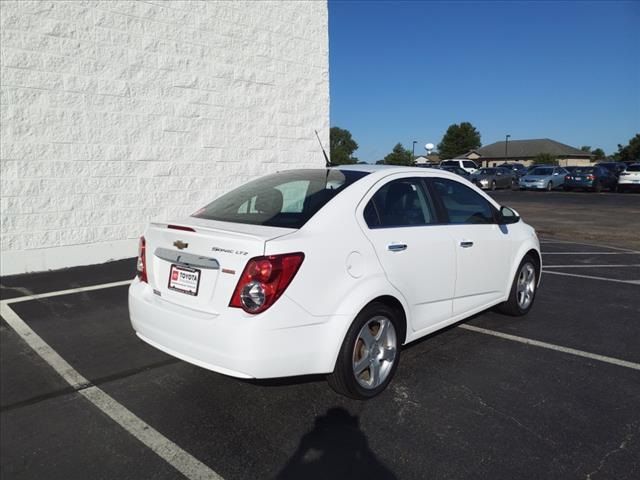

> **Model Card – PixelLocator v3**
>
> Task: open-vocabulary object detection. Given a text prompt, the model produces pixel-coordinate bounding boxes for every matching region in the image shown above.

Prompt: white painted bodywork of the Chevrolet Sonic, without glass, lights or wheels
[129,166,540,378]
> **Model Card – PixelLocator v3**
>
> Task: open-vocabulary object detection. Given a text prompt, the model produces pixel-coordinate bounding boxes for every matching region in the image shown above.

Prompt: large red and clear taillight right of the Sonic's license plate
[229,252,304,313]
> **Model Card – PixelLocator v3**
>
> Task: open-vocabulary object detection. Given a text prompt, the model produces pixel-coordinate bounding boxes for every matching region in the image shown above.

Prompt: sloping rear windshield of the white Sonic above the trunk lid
[192,169,368,228]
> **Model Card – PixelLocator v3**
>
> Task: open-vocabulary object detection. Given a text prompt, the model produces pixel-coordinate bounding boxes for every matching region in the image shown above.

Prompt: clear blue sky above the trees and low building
[329,0,640,162]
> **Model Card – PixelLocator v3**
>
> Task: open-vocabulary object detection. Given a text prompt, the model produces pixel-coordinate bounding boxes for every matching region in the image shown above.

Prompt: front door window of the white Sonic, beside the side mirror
[431,178,495,225]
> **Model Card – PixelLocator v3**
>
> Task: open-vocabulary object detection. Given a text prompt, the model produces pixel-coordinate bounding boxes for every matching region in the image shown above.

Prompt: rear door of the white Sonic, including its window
[364,176,456,331]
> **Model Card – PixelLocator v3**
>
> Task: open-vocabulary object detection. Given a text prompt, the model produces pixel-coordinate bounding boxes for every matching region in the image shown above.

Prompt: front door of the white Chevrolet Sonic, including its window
[428,177,512,315]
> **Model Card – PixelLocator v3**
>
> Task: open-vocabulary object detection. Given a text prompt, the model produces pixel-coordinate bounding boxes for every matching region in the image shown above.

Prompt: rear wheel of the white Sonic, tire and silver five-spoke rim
[327,302,404,400]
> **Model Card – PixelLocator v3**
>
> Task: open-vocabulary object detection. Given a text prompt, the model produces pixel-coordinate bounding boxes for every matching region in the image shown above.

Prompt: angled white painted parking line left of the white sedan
[0,298,222,480]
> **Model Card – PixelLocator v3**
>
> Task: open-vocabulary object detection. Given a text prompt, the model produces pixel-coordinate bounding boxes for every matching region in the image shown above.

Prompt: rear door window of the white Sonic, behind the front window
[364,178,436,228]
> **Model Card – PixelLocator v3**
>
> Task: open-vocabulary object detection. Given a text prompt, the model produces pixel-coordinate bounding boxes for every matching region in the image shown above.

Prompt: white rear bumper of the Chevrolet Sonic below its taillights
[129,280,342,378]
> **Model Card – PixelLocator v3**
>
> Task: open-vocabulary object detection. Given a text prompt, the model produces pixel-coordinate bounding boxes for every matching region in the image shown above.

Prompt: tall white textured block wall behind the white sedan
[0,0,329,275]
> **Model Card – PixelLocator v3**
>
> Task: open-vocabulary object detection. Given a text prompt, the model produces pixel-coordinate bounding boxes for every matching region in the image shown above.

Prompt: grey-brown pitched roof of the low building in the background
[465,138,591,160]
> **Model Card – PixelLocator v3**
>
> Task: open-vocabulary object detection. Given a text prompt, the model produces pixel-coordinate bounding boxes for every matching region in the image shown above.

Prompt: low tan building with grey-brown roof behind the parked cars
[458,138,592,167]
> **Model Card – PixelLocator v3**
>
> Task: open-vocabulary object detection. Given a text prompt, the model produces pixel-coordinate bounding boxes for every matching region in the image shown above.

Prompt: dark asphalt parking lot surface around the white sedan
[0,200,640,480]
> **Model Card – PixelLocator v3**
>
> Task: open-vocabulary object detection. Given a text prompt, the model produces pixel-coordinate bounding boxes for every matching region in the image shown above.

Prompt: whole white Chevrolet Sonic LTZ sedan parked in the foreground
[129,165,541,399]
